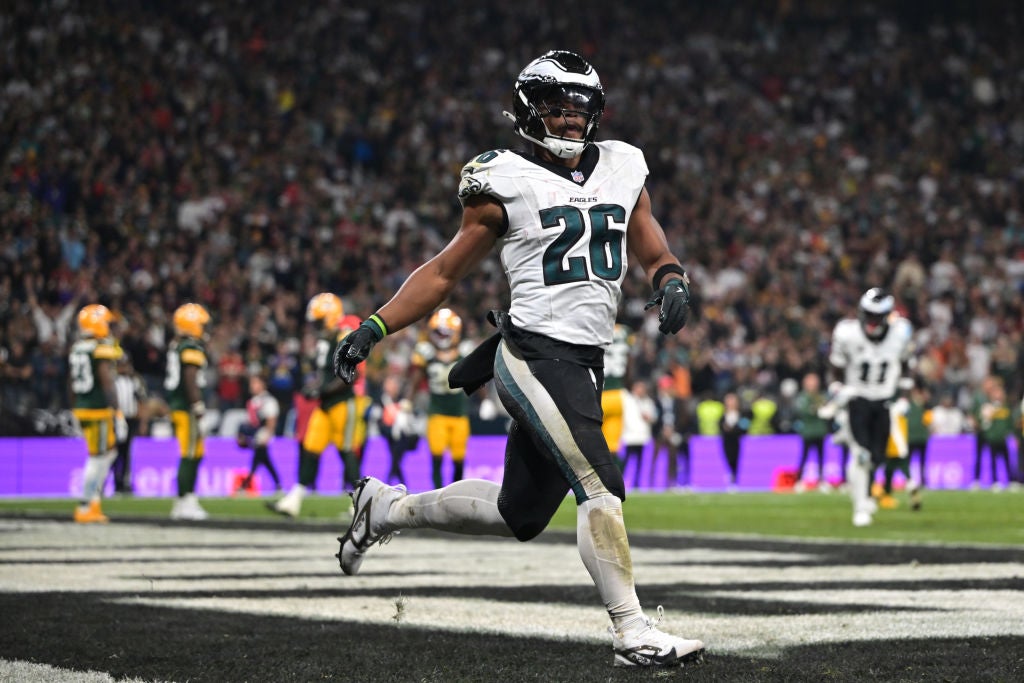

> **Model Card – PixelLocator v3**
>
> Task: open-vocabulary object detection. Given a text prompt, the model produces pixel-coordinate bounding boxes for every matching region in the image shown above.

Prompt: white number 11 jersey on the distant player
[828,316,913,400]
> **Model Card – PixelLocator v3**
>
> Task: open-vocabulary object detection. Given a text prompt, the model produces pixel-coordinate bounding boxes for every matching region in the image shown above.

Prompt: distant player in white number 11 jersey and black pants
[828,287,913,526]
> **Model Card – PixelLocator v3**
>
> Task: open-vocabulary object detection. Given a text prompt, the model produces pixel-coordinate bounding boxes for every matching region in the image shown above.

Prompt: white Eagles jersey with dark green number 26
[459,141,647,346]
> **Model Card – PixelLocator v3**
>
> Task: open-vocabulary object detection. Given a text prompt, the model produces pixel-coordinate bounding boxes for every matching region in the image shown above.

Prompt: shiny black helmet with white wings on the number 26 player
[503,50,604,159]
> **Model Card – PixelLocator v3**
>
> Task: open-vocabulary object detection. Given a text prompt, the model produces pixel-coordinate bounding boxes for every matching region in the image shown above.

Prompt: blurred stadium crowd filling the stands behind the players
[0,0,1024,454]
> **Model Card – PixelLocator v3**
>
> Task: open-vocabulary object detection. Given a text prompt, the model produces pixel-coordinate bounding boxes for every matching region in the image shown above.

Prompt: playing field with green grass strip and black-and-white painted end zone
[0,492,1024,682]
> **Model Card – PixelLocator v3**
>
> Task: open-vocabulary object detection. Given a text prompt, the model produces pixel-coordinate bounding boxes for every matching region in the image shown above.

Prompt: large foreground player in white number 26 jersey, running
[334,50,703,667]
